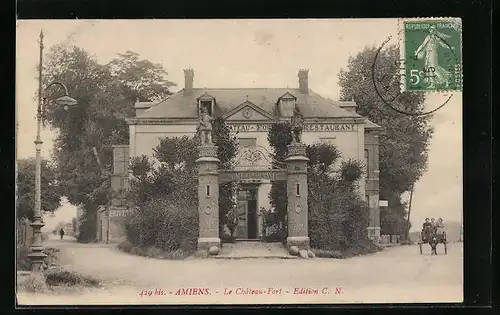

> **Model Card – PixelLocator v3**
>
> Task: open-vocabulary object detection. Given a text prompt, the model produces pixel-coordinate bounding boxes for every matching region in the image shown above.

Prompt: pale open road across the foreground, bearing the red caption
[17,239,463,305]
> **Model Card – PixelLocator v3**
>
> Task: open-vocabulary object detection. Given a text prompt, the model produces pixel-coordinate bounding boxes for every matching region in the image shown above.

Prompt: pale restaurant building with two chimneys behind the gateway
[106,69,381,240]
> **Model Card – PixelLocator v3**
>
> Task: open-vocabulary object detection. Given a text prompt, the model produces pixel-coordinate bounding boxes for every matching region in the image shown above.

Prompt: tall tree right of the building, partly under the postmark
[339,46,433,234]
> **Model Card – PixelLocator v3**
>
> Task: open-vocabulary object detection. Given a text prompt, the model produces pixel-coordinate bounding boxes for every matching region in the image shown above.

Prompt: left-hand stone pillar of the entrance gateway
[196,144,221,255]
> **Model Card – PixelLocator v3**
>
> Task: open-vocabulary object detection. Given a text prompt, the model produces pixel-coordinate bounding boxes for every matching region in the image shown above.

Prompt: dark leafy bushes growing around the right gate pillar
[263,123,369,251]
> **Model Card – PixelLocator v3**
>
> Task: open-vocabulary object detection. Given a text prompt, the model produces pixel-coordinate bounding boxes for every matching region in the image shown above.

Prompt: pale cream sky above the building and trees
[16,19,462,229]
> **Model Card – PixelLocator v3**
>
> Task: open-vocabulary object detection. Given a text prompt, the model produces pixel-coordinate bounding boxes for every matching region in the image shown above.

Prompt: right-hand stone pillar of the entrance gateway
[285,143,309,250]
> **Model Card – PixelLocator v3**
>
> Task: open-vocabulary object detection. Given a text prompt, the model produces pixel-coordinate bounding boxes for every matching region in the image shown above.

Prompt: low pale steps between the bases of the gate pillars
[212,241,297,259]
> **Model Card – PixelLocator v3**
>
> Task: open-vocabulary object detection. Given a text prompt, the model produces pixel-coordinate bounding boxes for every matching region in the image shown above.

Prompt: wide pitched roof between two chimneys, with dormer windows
[138,88,361,118]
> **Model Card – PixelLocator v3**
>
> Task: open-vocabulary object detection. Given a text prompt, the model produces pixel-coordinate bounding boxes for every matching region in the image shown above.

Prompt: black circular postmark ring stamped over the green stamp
[371,19,461,116]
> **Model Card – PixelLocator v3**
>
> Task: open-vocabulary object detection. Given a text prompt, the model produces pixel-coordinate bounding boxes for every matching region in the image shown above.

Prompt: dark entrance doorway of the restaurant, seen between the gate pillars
[235,184,259,240]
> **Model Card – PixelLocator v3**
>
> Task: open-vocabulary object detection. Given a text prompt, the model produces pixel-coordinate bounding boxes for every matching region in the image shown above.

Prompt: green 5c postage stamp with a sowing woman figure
[399,18,462,92]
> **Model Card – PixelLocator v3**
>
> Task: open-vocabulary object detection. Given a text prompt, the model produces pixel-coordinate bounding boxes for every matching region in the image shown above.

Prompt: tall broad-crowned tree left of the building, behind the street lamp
[43,46,178,241]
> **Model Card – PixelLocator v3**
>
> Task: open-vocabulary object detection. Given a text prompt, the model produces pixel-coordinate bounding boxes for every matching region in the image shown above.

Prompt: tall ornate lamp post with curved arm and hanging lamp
[28,31,77,272]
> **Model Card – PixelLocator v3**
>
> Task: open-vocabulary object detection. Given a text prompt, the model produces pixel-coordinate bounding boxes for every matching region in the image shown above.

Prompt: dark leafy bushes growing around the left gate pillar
[123,118,237,256]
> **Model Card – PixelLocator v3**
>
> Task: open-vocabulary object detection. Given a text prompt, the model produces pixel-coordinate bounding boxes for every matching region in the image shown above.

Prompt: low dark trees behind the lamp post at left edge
[16,158,61,220]
